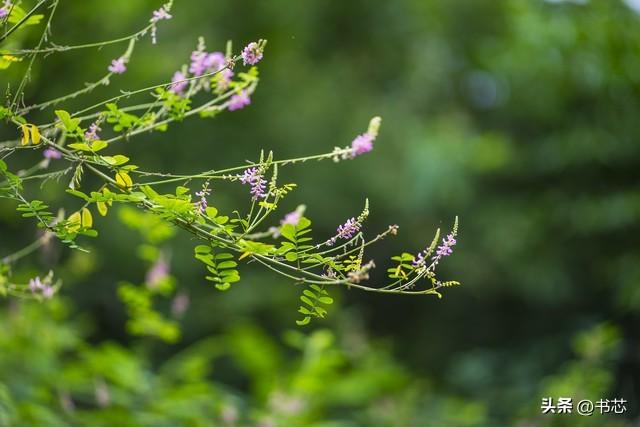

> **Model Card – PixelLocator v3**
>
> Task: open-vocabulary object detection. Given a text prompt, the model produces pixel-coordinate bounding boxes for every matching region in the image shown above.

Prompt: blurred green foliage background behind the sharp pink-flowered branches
[0,0,640,427]
